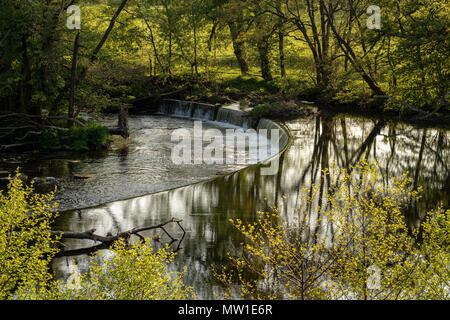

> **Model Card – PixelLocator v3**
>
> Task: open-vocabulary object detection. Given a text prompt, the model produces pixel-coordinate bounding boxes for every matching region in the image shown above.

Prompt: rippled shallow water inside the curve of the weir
[0,115,271,212]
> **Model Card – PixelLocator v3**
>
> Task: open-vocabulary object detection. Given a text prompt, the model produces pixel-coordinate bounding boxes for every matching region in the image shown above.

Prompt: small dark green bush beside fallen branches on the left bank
[40,124,109,151]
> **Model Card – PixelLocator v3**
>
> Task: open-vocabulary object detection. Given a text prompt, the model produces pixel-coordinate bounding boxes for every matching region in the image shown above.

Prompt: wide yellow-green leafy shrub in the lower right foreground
[216,162,450,299]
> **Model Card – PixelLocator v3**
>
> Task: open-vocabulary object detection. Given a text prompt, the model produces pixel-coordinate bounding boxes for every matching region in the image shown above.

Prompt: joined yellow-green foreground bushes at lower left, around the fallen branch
[0,171,192,300]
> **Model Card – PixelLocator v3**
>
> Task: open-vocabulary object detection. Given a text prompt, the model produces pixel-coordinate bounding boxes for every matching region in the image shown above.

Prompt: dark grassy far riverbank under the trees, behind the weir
[130,76,450,130]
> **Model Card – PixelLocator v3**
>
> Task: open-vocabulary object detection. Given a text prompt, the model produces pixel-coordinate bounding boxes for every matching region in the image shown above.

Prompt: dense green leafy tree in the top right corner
[374,0,450,112]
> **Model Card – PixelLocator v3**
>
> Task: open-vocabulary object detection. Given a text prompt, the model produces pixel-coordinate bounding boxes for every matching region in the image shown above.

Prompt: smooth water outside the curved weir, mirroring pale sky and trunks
[53,116,450,299]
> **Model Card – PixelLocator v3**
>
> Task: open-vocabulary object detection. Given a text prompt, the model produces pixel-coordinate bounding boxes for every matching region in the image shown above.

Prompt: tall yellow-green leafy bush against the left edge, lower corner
[0,171,57,300]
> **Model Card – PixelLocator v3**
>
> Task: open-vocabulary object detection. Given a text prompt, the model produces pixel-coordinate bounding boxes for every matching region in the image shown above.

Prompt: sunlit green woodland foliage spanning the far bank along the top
[0,0,449,121]
